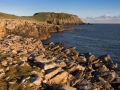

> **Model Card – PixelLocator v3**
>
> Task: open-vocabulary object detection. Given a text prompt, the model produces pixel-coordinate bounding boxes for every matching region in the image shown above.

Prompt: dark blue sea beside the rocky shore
[43,24,120,64]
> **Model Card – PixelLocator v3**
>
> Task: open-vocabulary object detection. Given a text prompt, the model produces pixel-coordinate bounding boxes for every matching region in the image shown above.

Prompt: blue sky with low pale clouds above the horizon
[0,0,120,23]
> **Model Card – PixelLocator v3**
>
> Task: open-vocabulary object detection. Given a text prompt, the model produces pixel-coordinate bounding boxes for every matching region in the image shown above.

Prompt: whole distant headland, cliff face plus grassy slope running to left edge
[0,12,85,25]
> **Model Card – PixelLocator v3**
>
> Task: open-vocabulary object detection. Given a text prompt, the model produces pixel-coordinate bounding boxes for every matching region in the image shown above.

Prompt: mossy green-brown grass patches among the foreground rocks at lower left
[0,54,43,90]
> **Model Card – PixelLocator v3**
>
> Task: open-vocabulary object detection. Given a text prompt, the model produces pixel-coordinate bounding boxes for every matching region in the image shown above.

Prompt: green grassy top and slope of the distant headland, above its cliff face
[0,12,82,22]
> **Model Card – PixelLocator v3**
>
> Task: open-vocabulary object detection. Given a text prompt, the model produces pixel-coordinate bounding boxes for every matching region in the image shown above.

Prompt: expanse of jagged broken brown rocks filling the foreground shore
[0,35,120,90]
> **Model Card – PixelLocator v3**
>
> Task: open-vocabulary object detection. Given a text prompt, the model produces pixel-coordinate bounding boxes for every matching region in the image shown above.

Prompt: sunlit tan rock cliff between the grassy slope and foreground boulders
[0,19,71,40]
